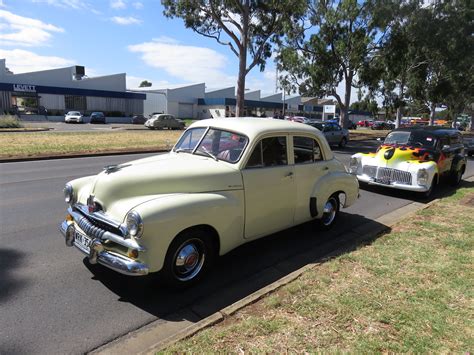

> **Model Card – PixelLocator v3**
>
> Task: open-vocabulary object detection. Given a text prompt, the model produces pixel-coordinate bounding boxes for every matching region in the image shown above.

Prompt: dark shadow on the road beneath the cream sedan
[84,212,389,321]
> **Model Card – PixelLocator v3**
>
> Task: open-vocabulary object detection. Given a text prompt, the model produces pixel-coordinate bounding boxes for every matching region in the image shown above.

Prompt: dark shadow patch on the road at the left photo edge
[0,248,26,304]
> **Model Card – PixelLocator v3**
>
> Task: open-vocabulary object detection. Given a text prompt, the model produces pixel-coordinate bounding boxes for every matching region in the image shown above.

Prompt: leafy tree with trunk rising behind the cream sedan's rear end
[278,0,390,127]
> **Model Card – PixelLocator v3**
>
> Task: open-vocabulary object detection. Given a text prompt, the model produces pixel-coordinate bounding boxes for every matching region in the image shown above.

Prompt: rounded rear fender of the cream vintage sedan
[311,171,359,218]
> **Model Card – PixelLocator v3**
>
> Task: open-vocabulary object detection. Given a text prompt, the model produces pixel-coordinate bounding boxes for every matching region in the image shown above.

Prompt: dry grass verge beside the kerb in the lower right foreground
[165,183,474,353]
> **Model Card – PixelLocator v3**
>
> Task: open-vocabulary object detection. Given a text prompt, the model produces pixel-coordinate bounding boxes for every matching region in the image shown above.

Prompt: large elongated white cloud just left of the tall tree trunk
[128,38,237,87]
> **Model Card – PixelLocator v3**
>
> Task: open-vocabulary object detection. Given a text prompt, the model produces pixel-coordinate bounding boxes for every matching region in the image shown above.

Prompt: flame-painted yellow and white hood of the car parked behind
[363,144,439,171]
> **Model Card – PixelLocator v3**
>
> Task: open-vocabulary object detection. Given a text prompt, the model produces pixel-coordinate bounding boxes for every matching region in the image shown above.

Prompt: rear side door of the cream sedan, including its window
[292,136,329,224]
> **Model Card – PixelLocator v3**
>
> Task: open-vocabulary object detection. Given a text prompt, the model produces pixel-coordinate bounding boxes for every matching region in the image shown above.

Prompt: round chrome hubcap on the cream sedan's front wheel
[173,239,205,281]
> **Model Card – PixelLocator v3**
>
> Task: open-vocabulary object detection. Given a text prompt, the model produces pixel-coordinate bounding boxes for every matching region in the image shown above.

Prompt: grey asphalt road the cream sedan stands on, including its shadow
[0,147,474,354]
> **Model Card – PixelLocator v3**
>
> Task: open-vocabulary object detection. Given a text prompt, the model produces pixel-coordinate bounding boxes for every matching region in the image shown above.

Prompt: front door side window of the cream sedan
[246,137,288,168]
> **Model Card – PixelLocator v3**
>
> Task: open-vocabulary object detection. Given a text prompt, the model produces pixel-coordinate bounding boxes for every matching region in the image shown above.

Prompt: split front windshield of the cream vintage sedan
[173,127,248,164]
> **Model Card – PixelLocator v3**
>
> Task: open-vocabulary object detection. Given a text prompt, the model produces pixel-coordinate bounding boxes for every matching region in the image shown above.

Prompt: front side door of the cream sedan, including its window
[242,135,296,239]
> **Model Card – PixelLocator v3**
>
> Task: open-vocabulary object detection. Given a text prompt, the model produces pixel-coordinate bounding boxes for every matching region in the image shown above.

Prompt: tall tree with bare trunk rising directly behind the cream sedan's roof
[162,0,306,117]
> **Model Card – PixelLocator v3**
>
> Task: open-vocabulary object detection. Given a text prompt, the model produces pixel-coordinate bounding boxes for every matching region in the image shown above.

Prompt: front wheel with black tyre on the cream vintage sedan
[163,229,215,288]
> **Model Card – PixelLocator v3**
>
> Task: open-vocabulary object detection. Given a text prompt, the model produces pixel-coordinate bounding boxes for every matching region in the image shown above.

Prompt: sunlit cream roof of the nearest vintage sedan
[190,117,321,139]
